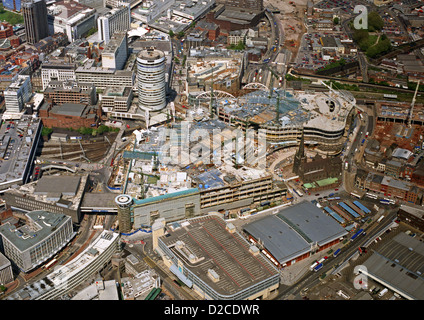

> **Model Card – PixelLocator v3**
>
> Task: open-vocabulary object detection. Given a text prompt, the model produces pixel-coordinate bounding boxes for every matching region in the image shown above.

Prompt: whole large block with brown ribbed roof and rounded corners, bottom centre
[153,214,280,300]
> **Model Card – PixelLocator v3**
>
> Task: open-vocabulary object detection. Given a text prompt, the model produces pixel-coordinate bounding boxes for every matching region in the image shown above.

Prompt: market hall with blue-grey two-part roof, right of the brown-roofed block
[243,201,347,267]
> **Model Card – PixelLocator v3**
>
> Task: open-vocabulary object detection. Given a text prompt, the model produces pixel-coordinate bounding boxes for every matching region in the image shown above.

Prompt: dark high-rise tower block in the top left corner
[22,0,49,44]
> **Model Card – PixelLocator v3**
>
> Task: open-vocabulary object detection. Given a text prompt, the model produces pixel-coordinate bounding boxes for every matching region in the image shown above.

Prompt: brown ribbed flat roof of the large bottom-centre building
[160,215,278,295]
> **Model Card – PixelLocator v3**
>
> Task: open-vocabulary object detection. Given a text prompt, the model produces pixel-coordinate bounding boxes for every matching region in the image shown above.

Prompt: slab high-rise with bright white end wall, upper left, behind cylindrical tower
[97,4,131,43]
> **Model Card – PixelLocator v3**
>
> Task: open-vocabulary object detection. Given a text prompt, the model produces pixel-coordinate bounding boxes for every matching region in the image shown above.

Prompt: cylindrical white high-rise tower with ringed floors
[137,48,166,111]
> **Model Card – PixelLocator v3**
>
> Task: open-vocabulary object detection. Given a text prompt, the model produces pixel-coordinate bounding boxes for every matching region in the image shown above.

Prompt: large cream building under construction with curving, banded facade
[217,90,356,152]
